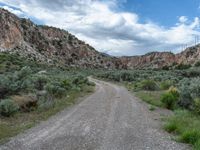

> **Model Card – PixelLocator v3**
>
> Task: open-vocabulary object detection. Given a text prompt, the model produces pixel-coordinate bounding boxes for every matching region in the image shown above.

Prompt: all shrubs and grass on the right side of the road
[96,67,200,150]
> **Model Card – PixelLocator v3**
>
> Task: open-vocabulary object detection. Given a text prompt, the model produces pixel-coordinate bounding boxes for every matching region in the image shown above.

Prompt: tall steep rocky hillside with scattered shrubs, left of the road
[0,8,117,68]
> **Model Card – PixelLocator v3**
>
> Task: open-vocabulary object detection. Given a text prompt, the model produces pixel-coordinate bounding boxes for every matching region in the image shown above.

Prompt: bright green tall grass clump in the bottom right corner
[164,110,200,150]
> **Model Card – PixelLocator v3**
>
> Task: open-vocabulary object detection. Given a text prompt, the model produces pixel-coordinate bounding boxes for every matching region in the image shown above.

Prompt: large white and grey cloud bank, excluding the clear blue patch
[0,0,200,55]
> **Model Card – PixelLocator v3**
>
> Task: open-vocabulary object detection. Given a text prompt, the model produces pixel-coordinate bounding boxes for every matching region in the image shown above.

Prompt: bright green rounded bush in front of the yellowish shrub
[161,92,178,109]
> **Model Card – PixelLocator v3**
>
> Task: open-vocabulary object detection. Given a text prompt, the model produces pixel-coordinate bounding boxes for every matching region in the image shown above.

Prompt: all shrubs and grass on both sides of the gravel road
[0,53,200,150]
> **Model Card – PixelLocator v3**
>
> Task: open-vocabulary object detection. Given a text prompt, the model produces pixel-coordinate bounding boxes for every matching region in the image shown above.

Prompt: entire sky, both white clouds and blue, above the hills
[0,0,200,56]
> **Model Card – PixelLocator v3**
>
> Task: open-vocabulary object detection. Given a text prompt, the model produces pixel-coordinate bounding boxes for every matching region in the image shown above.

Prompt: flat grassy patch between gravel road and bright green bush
[135,91,164,107]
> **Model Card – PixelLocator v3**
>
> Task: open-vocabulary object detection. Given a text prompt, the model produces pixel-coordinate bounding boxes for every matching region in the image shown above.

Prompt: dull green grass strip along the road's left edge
[0,86,94,144]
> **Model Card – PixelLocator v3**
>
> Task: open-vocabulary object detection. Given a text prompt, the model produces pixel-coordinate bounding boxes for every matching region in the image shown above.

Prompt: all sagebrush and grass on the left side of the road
[0,53,94,143]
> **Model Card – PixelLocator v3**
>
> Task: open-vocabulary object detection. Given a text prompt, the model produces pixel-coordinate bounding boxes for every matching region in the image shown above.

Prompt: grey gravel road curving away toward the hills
[0,79,190,150]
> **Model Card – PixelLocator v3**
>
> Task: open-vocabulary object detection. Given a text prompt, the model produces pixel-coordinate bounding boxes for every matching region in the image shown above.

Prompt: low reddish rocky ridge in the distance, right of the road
[120,44,200,69]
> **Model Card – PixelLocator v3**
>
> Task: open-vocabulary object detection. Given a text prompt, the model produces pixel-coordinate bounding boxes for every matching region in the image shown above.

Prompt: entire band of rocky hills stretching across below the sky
[0,8,200,69]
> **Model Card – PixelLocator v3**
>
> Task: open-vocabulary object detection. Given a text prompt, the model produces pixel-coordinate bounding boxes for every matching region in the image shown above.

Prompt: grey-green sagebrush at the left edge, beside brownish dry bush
[0,99,19,117]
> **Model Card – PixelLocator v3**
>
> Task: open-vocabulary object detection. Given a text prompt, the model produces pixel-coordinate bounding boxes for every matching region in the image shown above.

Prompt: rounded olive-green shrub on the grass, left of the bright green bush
[141,80,158,91]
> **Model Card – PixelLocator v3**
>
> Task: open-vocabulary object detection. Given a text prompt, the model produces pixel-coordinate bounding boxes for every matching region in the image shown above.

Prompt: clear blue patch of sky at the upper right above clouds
[122,0,200,27]
